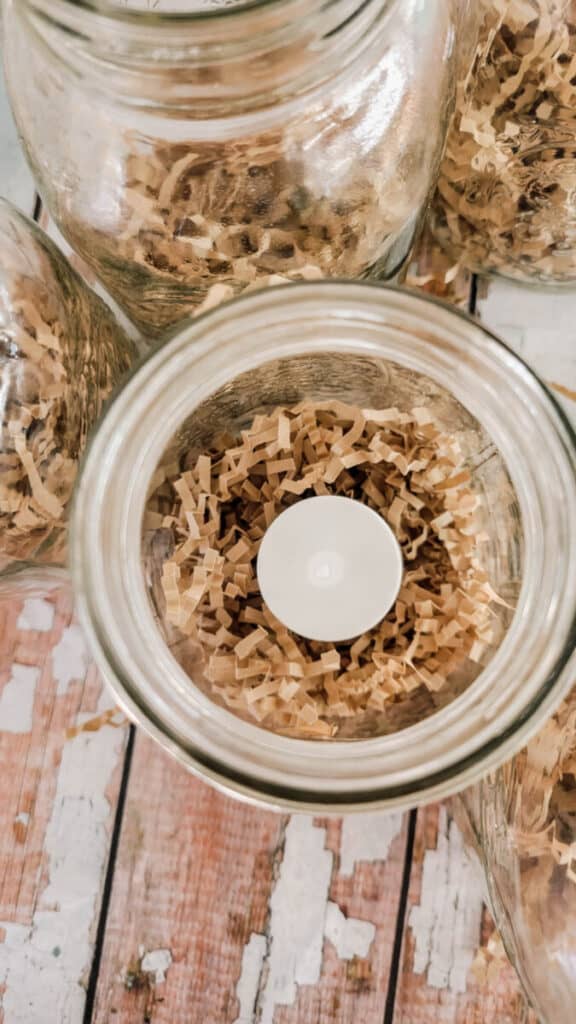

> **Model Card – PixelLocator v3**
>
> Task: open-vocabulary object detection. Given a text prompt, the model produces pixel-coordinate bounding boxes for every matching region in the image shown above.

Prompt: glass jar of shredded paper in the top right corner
[431,0,576,285]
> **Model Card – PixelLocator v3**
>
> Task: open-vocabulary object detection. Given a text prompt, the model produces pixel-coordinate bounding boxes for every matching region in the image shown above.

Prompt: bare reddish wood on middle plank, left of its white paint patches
[94,734,286,1024]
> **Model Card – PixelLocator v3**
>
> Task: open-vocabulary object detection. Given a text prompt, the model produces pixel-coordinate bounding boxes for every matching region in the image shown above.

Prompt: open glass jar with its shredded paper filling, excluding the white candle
[72,282,576,810]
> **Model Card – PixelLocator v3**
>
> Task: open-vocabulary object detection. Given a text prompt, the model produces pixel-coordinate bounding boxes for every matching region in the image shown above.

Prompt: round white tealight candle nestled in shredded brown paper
[257,496,403,643]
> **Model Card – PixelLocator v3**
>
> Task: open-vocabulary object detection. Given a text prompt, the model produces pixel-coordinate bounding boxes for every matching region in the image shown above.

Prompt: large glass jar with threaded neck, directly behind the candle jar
[4,0,462,333]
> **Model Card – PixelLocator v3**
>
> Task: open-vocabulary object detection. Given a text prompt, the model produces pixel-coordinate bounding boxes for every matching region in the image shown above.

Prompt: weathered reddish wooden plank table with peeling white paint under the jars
[0,58,576,1024]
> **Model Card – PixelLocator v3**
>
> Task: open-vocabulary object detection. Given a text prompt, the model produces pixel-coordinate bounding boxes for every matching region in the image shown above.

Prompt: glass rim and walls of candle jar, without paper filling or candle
[71,282,576,811]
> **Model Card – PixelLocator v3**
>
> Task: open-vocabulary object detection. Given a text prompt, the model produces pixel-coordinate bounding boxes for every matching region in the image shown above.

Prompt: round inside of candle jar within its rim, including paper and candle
[141,350,510,743]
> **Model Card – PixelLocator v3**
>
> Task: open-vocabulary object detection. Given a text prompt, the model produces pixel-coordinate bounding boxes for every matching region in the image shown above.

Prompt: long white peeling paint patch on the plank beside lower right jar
[408,807,485,992]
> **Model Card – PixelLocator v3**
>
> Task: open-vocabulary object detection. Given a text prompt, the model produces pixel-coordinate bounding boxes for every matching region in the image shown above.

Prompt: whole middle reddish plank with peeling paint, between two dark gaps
[93,735,405,1024]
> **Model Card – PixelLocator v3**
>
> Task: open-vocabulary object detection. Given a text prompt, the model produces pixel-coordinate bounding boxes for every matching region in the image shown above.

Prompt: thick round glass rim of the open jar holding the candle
[71,281,576,811]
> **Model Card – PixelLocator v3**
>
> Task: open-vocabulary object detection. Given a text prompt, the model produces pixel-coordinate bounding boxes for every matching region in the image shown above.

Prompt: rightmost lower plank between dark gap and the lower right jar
[394,805,537,1024]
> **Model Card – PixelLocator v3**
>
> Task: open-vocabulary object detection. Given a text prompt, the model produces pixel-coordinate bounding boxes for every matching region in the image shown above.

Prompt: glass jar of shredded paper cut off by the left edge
[0,200,134,588]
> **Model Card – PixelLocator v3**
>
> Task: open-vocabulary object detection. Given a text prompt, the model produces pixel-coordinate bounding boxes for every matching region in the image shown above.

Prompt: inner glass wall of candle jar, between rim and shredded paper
[141,352,524,740]
